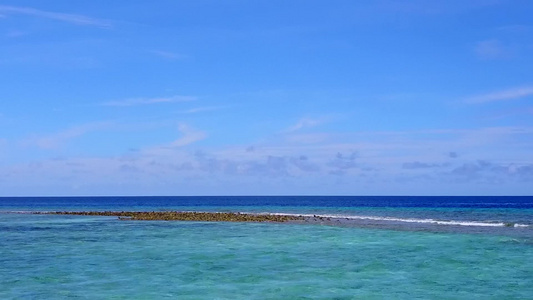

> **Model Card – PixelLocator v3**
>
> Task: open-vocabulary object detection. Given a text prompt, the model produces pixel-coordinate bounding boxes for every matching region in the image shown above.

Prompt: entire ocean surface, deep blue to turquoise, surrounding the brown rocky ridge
[0,196,533,299]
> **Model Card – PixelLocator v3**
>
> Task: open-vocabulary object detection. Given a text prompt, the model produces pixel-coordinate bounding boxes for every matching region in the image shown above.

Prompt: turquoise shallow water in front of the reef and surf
[0,214,533,299]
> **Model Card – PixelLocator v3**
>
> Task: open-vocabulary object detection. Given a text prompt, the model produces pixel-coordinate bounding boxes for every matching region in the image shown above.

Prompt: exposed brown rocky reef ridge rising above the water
[39,211,306,223]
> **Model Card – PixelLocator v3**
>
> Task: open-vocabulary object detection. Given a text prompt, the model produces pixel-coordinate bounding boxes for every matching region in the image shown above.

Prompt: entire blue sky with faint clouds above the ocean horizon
[0,0,533,196]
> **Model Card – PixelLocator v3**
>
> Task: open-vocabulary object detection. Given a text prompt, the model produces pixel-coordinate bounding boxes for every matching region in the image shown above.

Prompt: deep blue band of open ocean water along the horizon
[0,196,533,209]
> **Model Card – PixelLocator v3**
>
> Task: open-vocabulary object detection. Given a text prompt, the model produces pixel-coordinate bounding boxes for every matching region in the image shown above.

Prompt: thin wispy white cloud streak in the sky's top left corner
[0,5,111,28]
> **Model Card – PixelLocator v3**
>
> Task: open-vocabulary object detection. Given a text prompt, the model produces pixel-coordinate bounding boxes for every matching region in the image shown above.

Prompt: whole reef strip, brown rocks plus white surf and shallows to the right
[27,211,532,240]
